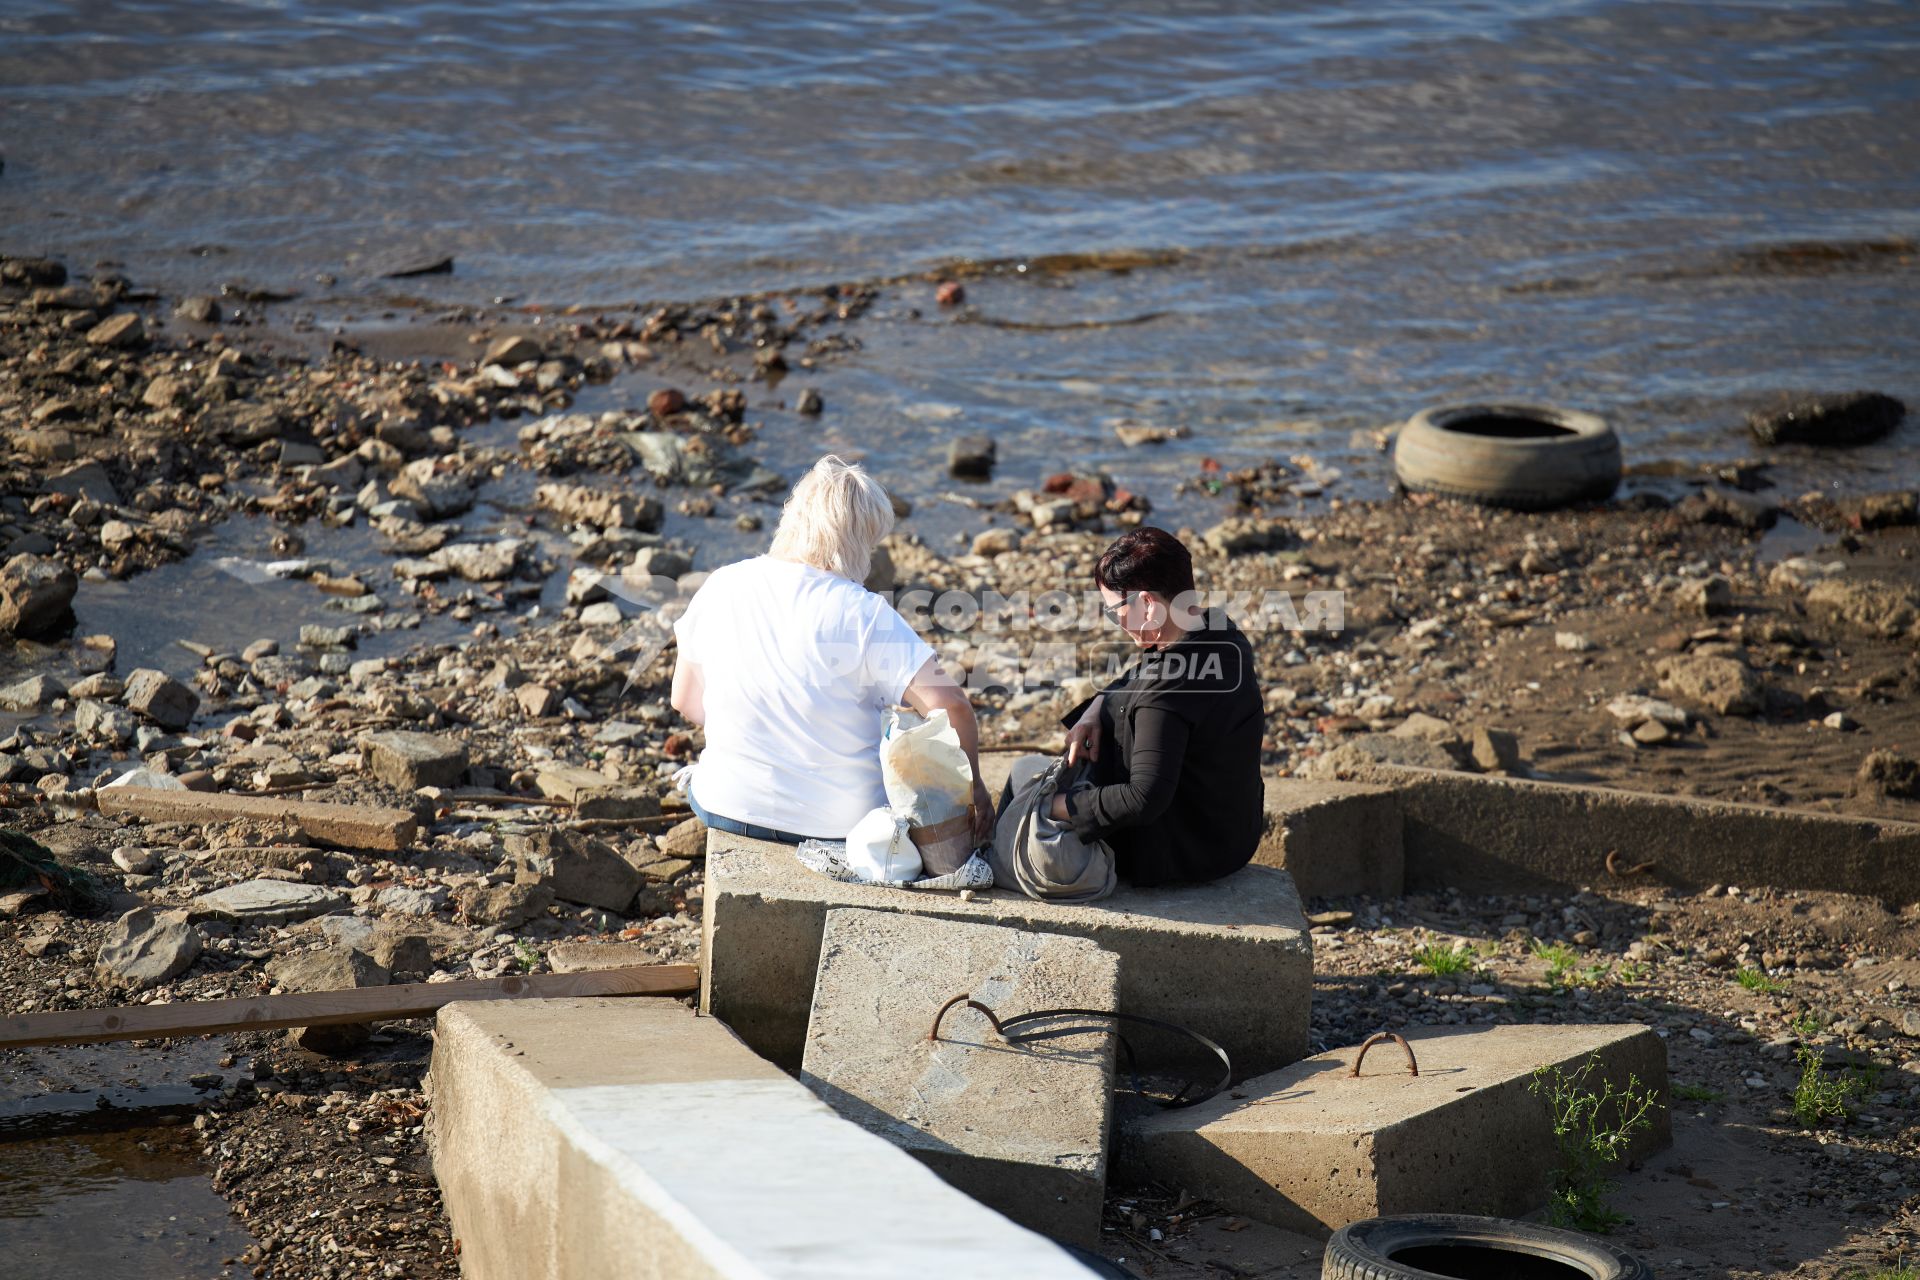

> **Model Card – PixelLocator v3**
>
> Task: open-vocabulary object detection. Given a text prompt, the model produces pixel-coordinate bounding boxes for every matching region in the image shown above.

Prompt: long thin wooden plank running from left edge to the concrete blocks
[0,965,701,1050]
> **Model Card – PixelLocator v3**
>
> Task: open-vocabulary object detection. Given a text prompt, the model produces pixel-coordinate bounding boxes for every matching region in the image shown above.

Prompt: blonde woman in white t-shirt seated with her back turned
[672,455,993,844]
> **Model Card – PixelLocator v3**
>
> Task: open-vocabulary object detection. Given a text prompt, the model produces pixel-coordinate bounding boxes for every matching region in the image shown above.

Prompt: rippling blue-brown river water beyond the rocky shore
[0,0,1920,510]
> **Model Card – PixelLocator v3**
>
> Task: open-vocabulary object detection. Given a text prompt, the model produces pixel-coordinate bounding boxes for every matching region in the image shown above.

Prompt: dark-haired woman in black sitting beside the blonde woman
[1052,528,1265,887]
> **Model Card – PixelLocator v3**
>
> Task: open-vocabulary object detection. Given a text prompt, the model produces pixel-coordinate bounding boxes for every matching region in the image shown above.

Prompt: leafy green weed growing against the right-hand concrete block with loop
[1526,1054,1659,1234]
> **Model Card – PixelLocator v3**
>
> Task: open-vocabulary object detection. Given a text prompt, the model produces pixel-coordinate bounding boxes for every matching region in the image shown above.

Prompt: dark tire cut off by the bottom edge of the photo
[1321,1213,1653,1280]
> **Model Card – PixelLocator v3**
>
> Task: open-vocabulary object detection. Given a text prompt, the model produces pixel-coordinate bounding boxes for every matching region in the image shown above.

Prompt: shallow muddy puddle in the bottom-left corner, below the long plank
[0,1040,252,1280]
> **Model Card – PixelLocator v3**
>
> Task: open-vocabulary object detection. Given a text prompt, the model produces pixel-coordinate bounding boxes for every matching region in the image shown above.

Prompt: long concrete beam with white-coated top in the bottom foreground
[432,998,1091,1280]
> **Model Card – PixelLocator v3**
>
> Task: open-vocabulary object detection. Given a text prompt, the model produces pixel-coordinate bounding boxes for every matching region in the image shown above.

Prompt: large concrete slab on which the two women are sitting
[701,831,1313,1079]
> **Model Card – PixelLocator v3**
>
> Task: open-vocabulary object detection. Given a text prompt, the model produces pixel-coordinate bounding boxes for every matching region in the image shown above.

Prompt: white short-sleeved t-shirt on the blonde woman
[674,557,933,841]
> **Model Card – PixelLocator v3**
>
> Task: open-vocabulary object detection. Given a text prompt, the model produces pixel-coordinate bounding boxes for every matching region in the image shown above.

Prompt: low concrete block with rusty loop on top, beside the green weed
[1123,1027,1672,1234]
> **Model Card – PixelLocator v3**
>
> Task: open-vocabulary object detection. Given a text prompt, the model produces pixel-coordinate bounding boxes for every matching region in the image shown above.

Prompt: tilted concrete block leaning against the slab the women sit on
[801,910,1119,1247]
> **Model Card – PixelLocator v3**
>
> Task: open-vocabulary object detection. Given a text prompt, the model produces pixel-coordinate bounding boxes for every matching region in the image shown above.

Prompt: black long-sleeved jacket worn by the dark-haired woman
[1062,608,1265,885]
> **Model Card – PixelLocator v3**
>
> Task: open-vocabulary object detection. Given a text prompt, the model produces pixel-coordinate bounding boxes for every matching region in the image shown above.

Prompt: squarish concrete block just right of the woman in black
[1254,777,1405,898]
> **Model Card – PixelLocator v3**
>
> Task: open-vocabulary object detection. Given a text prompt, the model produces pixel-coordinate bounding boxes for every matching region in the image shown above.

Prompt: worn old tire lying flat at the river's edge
[1394,405,1620,510]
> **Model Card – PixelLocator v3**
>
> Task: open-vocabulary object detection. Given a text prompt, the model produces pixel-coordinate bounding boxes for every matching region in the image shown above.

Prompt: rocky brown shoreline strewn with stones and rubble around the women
[0,259,1920,1276]
